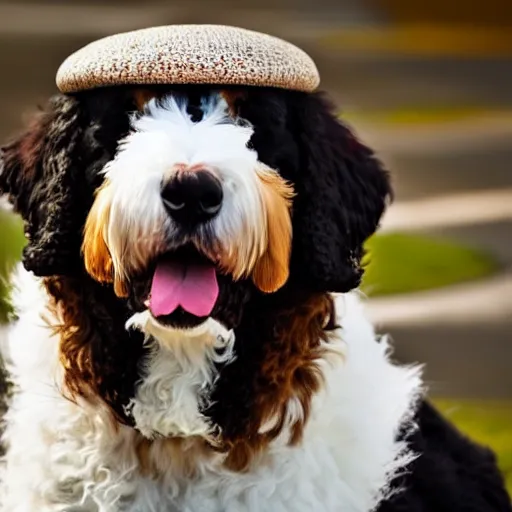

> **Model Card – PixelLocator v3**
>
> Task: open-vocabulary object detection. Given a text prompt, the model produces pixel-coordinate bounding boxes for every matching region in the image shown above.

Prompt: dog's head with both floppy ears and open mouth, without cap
[0,87,390,327]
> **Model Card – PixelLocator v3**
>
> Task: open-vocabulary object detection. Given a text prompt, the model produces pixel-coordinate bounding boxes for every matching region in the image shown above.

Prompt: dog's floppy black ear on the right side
[288,94,391,292]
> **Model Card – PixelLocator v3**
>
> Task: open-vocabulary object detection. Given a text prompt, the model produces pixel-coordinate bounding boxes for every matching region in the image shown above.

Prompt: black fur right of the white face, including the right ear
[240,89,391,292]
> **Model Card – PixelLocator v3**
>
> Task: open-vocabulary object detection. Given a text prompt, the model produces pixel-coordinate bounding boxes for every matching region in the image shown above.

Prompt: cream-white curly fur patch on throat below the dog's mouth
[128,311,235,438]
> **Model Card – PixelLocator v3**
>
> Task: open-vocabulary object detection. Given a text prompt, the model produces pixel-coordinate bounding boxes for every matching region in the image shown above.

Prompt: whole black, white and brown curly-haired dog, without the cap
[0,39,512,512]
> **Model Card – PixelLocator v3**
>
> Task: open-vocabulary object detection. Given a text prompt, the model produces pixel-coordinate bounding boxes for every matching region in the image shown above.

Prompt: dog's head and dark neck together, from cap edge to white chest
[0,87,390,462]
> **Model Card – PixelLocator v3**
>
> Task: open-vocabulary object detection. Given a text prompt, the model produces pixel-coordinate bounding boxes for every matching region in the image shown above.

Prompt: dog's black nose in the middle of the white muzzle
[161,171,223,224]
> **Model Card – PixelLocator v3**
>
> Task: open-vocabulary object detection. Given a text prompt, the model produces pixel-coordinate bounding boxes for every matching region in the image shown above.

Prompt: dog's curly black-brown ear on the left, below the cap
[0,93,132,276]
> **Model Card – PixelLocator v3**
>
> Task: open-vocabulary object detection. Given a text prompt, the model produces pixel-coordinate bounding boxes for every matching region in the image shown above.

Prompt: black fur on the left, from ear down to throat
[0,90,143,423]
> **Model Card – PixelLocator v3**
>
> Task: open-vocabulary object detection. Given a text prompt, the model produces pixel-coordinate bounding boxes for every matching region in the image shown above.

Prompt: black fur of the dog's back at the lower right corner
[376,402,512,512]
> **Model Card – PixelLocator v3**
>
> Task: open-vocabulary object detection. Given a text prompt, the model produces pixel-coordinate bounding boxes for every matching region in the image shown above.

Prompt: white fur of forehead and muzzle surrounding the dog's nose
[104,95,267,277]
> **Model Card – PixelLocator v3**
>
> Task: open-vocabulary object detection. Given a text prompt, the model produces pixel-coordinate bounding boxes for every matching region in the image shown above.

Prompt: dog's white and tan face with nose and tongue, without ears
[82,92,293,327]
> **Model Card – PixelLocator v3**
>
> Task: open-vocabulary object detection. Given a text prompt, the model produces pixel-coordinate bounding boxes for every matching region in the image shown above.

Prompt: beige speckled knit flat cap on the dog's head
[57,25,320,93]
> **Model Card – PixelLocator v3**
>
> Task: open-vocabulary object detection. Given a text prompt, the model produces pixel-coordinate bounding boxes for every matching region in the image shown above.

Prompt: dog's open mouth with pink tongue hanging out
[141,246,219,328]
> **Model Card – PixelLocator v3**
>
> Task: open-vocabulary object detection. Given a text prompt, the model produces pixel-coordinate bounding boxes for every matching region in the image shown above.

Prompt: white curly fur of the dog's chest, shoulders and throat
[1,272,421,512]
